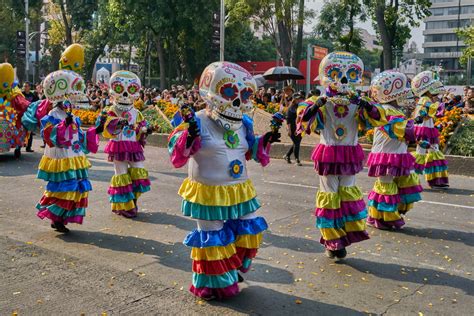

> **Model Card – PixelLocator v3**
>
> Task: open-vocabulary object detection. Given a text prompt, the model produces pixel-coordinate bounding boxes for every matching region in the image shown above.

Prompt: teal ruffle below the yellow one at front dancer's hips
[181,198,260,221]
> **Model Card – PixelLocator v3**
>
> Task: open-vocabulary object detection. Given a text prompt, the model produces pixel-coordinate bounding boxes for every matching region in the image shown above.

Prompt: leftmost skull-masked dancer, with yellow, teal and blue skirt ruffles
[36,70,103,233]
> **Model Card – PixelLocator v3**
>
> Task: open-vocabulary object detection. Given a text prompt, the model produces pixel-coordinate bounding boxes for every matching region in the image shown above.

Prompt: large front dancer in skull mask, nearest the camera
[168,62,281,299]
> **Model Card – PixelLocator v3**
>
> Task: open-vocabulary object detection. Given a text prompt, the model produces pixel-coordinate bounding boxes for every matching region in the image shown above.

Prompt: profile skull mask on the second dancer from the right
[370,70,411,103]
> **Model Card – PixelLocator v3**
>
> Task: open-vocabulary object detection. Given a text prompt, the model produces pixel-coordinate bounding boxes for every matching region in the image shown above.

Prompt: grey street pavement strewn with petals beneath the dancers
[0,140,474,315]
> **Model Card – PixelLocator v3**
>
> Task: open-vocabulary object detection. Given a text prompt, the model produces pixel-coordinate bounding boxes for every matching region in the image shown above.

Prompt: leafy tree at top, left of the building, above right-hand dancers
[363,0,431,70]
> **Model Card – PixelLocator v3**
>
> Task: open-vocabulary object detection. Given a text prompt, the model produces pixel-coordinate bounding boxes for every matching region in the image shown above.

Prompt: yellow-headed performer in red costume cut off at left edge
[0,63,30,159]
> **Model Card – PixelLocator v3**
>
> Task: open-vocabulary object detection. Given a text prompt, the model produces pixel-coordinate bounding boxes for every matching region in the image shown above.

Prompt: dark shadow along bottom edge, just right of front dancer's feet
[209,286,362,316]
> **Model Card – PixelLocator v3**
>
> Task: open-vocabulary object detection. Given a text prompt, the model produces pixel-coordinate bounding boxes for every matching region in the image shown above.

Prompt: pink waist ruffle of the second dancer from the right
[367,153,415,177]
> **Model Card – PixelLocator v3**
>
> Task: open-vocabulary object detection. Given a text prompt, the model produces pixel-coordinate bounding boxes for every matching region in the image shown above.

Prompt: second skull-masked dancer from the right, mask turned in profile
[367,71,423,229]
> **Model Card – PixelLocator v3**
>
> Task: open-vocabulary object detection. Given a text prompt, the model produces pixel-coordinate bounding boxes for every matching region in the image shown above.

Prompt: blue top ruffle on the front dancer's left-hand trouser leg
[183,226,235,248]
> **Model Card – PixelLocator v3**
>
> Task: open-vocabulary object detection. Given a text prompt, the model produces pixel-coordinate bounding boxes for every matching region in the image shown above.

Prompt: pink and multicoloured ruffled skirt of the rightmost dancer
[413,126,449,187]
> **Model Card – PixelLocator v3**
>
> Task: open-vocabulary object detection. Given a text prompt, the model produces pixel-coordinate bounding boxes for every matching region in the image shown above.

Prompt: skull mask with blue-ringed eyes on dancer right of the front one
[319,52,364,94]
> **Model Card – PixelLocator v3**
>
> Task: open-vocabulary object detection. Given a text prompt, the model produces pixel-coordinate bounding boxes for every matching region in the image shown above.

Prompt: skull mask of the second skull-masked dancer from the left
[109,70,142,109]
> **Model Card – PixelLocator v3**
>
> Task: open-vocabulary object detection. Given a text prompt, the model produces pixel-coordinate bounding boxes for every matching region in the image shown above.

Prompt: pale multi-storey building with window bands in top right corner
[423,0,474,80]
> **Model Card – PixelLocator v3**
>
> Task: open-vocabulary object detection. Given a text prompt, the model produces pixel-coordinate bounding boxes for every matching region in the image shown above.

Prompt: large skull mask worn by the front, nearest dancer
[199,62,257,131]
